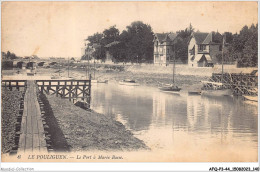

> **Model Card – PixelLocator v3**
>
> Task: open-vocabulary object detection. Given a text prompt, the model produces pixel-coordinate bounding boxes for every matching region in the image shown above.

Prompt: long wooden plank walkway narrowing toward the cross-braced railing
[18,80,47,153]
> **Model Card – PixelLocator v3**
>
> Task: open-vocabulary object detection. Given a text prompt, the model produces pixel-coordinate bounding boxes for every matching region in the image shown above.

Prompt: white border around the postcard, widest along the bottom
[0,0,260,172]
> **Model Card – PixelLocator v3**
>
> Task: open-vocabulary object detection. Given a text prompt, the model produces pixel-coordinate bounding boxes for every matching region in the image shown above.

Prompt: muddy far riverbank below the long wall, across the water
[25,65,209,91]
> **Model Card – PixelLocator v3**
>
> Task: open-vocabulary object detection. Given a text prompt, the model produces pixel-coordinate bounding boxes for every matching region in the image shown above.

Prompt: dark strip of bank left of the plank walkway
[1,89,22,153]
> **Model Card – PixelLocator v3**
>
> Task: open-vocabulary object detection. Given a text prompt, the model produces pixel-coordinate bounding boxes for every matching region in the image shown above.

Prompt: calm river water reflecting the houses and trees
[91,83,258,161]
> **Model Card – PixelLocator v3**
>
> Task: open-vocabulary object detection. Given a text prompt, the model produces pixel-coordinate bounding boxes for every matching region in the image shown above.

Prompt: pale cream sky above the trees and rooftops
[1,1,258,58]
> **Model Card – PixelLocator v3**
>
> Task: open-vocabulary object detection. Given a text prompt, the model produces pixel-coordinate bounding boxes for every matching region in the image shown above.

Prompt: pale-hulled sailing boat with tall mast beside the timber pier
[201,35,233,96]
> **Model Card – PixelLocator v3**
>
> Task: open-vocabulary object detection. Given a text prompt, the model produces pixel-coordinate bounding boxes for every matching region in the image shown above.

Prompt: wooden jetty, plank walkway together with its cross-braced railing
[2,80,91,153]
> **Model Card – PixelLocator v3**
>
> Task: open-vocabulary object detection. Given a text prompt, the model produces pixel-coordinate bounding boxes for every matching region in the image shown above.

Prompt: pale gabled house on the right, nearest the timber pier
[188,32,223,67]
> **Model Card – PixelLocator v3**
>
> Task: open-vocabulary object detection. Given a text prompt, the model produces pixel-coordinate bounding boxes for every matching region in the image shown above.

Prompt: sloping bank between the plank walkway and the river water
[43,95,148,151]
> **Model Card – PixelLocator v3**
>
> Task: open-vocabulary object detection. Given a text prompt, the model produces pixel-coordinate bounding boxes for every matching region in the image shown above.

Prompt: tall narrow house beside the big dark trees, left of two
[153,33,177,65]
